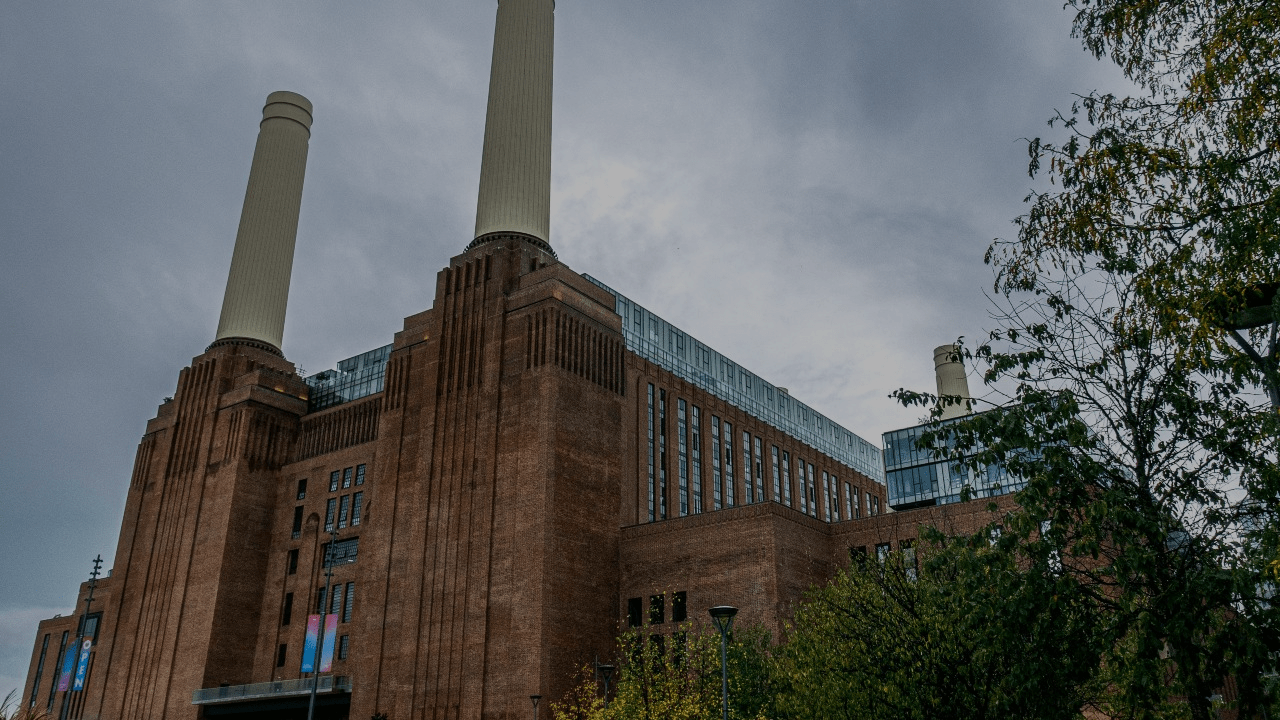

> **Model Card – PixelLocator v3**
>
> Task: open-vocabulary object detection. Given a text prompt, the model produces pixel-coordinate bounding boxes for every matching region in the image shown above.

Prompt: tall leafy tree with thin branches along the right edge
[900,0,1280,720]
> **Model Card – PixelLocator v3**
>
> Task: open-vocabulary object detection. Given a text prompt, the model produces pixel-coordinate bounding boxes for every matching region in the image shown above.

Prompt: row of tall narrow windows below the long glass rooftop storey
[645,383,881,523]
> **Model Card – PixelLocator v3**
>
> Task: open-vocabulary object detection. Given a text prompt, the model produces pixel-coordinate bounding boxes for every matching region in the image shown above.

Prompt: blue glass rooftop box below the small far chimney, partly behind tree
[884,418,1027,510]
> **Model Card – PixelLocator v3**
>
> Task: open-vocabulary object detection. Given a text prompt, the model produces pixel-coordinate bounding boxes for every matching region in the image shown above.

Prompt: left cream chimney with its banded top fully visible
[214,91,311,351]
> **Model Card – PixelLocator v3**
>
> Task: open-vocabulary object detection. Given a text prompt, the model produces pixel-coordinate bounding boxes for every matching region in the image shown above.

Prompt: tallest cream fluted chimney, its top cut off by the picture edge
[471,0,556,250]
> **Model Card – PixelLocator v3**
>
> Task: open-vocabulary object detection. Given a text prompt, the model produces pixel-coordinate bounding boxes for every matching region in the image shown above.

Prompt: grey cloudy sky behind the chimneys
[0,0,1119,694]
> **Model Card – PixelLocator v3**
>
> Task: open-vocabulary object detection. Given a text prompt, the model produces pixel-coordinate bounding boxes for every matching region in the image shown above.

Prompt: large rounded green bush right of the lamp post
[777,532,1096,720]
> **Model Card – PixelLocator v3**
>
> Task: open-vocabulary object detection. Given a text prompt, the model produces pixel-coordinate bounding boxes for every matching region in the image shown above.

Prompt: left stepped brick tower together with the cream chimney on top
[86,92,311,719]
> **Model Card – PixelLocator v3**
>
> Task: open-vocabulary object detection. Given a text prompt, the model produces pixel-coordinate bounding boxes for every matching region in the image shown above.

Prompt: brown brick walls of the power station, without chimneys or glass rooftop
[24,236,987,720]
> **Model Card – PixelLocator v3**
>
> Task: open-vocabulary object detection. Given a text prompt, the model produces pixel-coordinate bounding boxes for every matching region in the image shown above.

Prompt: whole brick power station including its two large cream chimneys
[22,0,998,720]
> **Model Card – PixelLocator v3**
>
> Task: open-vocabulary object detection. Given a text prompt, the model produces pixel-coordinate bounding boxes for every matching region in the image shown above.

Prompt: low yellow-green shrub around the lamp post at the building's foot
[552,624,773,720]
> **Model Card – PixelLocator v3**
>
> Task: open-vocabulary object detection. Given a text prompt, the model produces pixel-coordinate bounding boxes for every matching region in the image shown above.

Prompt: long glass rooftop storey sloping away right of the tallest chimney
[582,275,884,482]
